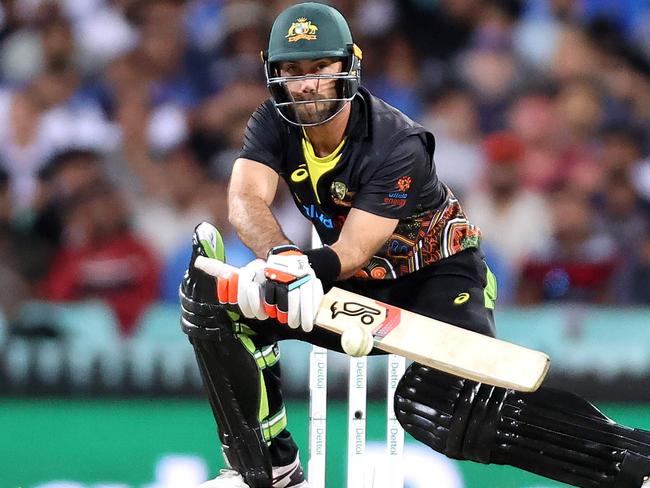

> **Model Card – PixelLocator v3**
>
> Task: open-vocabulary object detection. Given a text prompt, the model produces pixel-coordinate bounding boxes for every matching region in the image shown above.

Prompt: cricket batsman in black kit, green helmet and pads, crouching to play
[180,3,650,488]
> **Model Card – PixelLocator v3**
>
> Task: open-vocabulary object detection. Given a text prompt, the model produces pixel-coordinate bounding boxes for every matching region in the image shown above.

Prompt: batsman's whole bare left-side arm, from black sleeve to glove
[228,158,290,258]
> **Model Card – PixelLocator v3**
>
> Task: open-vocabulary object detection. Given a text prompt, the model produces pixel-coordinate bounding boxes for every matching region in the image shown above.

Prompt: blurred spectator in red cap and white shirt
[464,132,551,302]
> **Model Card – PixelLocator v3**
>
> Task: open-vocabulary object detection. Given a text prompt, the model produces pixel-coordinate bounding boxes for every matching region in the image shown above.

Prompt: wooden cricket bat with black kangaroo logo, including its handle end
[195,256,550,391]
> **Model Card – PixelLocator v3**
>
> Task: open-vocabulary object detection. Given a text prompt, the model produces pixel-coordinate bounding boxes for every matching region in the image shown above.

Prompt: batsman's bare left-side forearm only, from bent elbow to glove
[228,195,291,259]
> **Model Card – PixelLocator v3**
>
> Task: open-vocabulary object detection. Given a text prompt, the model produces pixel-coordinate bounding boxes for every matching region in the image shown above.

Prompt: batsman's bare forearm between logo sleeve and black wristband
[332,208,398,279]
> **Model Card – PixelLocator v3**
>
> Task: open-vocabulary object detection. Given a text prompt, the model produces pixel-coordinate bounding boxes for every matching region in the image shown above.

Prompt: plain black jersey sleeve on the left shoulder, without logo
[239,102,282,173]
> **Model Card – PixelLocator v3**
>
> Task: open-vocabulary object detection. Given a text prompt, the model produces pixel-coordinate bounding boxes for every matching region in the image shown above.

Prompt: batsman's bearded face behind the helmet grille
[279,58,343,124]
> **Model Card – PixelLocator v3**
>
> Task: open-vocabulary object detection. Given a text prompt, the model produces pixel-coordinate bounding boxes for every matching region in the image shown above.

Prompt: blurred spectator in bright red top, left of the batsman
[41,180,160,336]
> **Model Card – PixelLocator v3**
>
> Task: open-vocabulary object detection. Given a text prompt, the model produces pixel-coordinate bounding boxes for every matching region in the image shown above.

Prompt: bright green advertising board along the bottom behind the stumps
[0,399,650,488]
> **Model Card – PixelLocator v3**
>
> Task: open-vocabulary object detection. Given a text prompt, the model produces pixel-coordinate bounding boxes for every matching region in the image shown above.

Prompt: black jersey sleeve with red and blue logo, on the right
[352,136,432,219]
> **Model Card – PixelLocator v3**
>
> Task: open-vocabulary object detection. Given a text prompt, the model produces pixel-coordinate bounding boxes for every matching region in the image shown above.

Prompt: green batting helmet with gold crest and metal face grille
[263,2,361,126]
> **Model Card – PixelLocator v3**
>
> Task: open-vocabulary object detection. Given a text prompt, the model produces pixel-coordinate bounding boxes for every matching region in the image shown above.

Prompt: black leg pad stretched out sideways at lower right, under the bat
[395,363,650,488]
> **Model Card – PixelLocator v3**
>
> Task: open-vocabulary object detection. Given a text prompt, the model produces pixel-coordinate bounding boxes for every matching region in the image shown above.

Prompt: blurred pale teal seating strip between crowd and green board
[0,301,650,395]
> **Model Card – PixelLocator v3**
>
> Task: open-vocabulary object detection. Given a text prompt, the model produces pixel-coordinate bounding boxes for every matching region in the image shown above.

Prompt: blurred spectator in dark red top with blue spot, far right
[517,183,619,305]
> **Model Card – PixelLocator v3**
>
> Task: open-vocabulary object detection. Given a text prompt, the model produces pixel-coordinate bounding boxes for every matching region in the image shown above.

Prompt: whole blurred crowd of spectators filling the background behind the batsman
[0,0,650,335]
